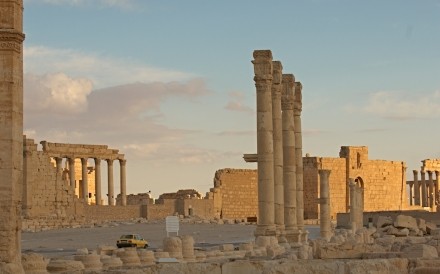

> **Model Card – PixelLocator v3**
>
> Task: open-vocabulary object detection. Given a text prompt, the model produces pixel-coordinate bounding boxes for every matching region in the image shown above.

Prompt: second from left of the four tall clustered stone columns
[272,61,286,242]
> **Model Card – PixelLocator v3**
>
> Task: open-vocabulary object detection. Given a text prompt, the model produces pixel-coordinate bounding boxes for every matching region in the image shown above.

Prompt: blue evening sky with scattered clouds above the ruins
[24,0,440,198]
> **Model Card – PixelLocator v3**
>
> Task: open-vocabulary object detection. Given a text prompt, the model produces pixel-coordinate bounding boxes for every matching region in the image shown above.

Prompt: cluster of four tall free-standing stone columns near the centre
[252,50,306,243]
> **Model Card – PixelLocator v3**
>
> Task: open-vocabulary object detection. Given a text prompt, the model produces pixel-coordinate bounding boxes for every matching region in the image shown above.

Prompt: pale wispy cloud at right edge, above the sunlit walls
[363,91,440,120]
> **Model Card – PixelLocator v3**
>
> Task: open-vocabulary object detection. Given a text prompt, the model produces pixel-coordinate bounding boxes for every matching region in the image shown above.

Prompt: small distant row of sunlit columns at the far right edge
[409,170,439,211]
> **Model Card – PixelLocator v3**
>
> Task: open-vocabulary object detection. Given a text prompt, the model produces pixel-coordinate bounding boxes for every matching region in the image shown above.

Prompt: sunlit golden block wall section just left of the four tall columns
[212,168,258,219]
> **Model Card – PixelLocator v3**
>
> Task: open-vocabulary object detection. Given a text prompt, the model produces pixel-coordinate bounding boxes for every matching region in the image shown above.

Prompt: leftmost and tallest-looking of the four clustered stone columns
[252,50,276,236]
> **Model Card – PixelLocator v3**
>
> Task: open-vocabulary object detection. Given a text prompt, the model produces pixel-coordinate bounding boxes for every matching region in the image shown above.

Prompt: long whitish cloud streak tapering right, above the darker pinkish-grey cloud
[24,46,196,88]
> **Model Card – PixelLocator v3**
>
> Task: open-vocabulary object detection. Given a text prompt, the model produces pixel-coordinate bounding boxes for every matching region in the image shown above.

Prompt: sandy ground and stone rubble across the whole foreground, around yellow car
[22,213,440,274]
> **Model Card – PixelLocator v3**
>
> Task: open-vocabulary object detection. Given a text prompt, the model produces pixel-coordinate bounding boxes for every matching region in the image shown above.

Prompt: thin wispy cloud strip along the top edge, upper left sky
[25,0,137,9]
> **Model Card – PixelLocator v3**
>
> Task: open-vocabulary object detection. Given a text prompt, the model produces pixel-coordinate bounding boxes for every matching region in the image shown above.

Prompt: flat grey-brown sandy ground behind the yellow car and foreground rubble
[21,222,319,258]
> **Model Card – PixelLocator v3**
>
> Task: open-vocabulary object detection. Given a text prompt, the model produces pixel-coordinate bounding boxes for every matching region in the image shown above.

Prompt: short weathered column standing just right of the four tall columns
[319,169,332,241]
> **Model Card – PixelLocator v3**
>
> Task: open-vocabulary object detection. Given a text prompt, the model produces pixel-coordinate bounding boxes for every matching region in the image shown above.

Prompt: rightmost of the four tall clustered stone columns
[293,82,304,231]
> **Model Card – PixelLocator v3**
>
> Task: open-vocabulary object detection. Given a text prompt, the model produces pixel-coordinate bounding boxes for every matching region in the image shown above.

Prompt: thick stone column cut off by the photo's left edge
[0,0,24,273]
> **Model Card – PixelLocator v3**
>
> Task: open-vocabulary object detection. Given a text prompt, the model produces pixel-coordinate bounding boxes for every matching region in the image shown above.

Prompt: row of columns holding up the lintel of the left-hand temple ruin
[55,157,127,206]
